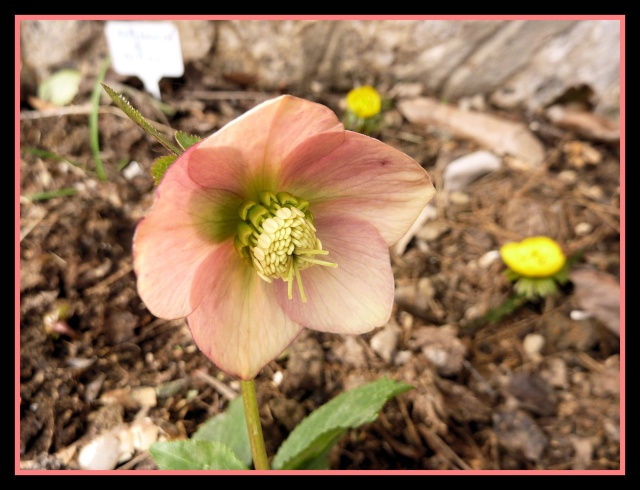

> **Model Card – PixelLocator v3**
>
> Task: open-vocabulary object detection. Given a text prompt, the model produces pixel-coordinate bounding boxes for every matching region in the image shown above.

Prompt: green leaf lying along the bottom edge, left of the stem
[149,439,249,470]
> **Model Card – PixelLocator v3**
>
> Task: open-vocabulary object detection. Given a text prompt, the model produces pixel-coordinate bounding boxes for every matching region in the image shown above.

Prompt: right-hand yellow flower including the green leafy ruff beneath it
[500,236,568,299]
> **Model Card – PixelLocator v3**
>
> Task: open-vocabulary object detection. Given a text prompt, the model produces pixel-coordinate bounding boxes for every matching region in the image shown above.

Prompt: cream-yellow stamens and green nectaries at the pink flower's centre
[234,192,338,302]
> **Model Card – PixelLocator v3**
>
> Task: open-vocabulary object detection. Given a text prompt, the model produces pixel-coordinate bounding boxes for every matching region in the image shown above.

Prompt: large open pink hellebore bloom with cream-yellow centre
[133,95,435,380]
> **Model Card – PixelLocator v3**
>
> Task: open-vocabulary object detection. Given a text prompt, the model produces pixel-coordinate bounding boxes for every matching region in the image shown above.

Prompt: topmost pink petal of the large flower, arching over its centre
[191,95,344,198]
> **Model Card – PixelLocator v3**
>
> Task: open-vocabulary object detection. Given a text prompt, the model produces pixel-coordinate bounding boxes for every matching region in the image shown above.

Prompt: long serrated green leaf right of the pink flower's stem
[272,378,413,470]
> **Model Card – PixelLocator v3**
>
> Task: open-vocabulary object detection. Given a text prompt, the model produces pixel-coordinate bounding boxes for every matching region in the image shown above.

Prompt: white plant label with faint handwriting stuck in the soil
[105,21,184,99]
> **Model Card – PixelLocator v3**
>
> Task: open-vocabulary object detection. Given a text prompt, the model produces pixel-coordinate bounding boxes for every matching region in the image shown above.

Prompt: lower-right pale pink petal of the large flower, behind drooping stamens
[276,216,394,334]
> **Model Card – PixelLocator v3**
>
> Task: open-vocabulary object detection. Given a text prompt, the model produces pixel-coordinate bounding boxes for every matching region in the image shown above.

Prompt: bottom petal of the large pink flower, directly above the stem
[187,244,303,380]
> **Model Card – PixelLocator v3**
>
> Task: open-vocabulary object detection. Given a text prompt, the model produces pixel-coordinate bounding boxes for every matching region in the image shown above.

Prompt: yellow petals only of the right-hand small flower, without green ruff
[500,236,566,278]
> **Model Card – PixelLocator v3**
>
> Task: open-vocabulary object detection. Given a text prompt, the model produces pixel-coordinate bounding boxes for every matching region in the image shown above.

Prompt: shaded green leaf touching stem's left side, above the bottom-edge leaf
[191,396,253,466]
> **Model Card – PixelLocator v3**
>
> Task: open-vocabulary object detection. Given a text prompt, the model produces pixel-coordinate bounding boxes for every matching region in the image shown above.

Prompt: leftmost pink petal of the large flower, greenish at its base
[133,150,240,318]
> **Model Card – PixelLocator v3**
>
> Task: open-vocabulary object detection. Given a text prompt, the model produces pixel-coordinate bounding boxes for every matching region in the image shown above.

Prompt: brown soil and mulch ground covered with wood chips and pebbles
[19,61,623,470]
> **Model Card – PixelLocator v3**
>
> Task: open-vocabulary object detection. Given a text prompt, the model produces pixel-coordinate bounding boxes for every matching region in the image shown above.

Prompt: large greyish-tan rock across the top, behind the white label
[20,19,620,113]
